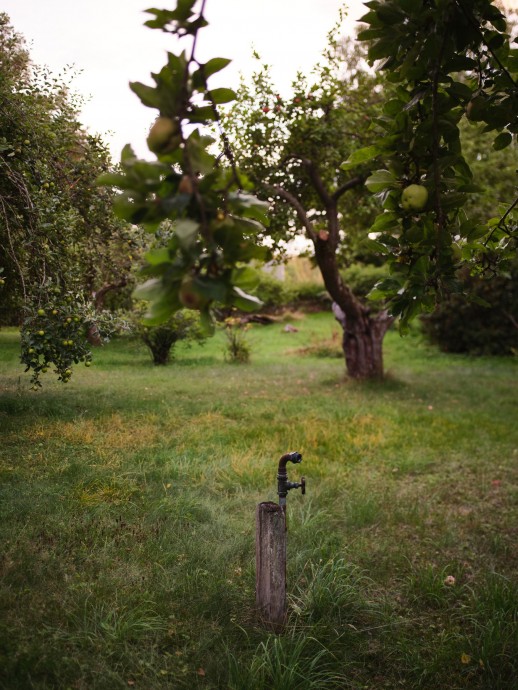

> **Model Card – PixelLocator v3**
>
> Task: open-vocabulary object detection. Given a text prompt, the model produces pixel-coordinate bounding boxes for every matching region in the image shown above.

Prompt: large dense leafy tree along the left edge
[0,14,138,387]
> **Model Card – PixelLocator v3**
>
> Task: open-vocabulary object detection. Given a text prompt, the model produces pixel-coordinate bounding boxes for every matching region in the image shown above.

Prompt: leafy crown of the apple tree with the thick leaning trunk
[226,33,384,264]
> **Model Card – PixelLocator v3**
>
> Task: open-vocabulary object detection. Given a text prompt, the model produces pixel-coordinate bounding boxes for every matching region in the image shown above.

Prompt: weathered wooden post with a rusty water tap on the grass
[255,453,306,631]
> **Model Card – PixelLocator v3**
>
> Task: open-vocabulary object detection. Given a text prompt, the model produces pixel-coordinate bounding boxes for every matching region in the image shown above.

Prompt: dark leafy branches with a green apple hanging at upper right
[350,0,518,329]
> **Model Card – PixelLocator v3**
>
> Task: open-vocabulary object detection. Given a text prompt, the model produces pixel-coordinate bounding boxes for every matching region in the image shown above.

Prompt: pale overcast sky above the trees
[0,0,367,160]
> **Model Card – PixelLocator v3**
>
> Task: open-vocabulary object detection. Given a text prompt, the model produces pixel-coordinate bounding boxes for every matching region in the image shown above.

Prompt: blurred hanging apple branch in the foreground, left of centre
[100,0,268,328]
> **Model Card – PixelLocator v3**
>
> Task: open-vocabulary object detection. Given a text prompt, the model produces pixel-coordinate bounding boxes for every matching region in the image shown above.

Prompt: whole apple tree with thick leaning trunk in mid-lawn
[228,35,393,379]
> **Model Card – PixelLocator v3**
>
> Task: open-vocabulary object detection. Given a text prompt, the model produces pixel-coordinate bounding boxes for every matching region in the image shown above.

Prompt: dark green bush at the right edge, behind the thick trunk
[421,265,518,355]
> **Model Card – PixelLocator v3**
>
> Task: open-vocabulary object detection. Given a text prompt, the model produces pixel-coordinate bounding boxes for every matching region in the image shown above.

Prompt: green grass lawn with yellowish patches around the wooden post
[0,314,518,690]
